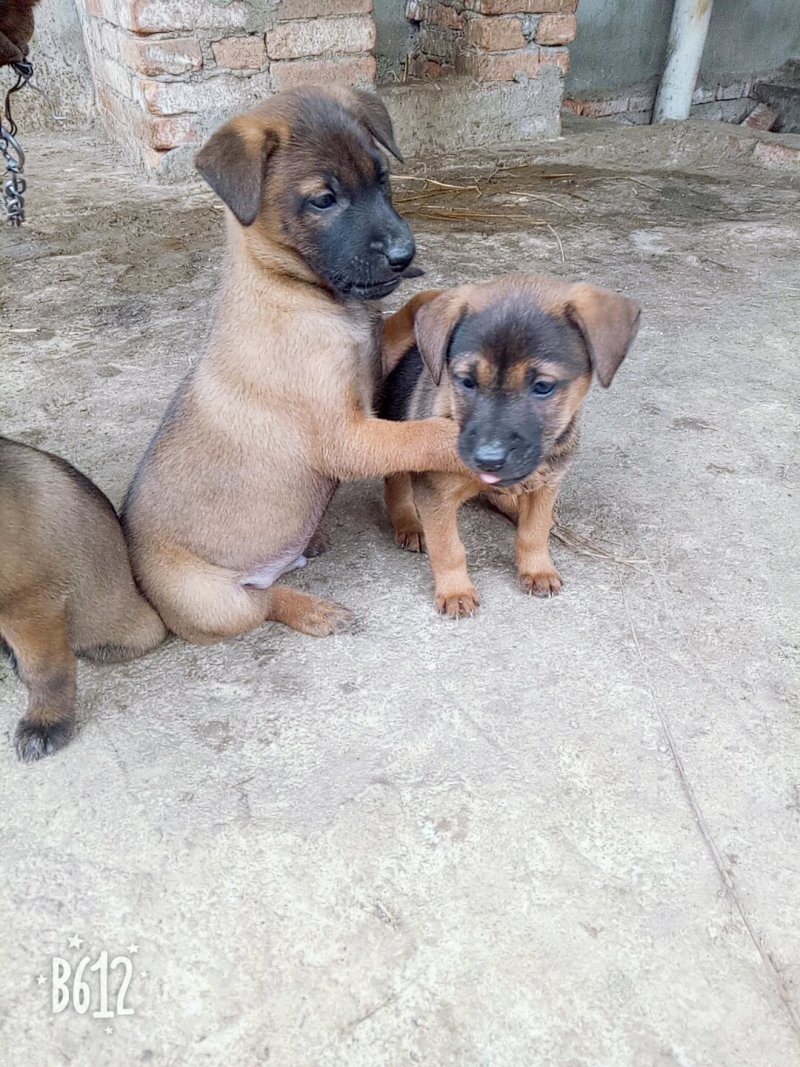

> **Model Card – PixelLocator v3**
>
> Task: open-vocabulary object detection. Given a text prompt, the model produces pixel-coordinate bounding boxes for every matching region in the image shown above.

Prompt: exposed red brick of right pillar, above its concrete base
[406,0,578,82]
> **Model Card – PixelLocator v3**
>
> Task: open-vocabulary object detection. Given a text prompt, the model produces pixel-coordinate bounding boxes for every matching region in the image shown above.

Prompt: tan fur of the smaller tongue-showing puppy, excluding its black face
[383,274,639,618]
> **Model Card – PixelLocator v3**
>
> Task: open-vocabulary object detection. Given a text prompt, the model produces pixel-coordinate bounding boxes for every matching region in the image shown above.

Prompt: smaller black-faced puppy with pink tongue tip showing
[381,274,639,618]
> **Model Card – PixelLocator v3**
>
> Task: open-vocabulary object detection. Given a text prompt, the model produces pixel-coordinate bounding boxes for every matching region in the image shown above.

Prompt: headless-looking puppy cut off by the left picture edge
[0,437,166,762]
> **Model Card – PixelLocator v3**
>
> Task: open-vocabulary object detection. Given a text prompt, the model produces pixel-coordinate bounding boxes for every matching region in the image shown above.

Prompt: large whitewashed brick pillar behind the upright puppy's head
[79,0,375,176]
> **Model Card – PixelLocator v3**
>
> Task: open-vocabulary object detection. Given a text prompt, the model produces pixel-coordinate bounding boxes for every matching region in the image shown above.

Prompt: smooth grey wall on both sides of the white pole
[566,0,800,93]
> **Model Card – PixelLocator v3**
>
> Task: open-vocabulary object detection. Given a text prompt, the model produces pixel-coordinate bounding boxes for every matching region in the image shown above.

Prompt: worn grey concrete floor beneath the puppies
[0,124,800,1067]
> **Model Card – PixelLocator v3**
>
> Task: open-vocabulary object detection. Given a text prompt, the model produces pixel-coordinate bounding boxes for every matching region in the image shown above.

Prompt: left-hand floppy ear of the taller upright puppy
[194,115,288,226]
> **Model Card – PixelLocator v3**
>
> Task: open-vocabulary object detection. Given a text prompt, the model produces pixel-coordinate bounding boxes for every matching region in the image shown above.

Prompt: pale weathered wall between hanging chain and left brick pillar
[0,0,94,130]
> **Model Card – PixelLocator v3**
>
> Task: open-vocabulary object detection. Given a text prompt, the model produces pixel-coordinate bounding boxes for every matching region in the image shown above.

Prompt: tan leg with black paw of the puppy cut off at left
[0,591,76,763]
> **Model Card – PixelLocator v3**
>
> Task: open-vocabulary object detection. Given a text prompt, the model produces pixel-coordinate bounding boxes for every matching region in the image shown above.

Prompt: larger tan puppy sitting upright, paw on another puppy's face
[124,89,461,642]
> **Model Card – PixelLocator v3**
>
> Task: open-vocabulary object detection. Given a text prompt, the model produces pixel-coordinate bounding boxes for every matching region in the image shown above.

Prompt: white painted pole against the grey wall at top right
[653,0,714,123]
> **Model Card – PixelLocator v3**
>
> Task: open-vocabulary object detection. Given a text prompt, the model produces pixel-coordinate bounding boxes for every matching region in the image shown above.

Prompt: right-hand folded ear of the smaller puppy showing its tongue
[564,285,641,388]
